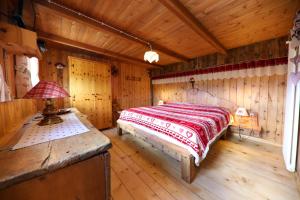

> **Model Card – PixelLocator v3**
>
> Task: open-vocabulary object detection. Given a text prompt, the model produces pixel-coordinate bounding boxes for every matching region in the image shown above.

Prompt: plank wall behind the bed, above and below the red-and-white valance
[152,37,287,144]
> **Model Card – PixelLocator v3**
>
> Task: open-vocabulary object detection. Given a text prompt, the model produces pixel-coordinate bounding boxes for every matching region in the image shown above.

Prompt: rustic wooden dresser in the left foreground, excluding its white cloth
[0,109,111,200]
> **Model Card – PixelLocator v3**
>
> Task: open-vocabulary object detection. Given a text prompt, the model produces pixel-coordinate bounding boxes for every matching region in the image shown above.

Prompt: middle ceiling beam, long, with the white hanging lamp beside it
[34,0,189,62]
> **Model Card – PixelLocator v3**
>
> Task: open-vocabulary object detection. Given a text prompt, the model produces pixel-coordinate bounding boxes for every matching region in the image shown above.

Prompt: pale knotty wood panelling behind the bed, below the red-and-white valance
[153,75,286,144]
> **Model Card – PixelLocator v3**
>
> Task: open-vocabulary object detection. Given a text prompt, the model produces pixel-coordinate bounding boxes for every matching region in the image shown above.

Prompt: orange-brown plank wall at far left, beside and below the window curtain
[0,48,37,146]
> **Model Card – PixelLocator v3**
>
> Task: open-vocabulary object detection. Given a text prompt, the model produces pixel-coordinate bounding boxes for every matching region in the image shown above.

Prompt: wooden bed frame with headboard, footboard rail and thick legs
[117,89,236,183]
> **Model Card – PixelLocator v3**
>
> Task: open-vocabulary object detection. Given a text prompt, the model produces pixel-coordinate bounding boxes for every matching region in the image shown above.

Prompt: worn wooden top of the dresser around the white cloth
[0,109,111,189]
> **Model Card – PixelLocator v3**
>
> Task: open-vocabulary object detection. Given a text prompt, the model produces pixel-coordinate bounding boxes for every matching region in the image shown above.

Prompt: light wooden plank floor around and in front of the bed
[103,129,300,200]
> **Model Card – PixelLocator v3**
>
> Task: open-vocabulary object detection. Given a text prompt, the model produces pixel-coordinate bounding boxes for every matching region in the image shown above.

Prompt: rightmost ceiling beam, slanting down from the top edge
[159,0,226,54]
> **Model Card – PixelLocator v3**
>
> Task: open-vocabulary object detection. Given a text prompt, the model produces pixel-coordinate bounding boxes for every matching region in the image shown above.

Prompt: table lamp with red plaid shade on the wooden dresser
[23,81,70,126]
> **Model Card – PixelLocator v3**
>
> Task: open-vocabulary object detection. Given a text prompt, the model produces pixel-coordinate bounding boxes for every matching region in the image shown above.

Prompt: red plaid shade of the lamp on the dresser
[23,81,70,99]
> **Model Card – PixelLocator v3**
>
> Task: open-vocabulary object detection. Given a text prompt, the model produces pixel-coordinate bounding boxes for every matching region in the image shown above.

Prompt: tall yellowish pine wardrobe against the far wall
[69,57,112,129]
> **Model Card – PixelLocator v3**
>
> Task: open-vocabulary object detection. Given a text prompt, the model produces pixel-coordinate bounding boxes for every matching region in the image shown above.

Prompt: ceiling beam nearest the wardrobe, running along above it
[38,32,161,67]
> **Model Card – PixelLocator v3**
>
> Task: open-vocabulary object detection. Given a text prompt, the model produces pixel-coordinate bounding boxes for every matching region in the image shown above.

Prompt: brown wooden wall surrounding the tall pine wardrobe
[38,45,151,120]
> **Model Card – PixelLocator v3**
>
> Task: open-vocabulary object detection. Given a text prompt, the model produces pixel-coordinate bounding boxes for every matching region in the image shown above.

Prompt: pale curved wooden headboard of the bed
[185,88,238,113]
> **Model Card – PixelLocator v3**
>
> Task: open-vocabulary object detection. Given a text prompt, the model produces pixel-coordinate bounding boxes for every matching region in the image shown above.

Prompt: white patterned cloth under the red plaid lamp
[12,113,89,150]
